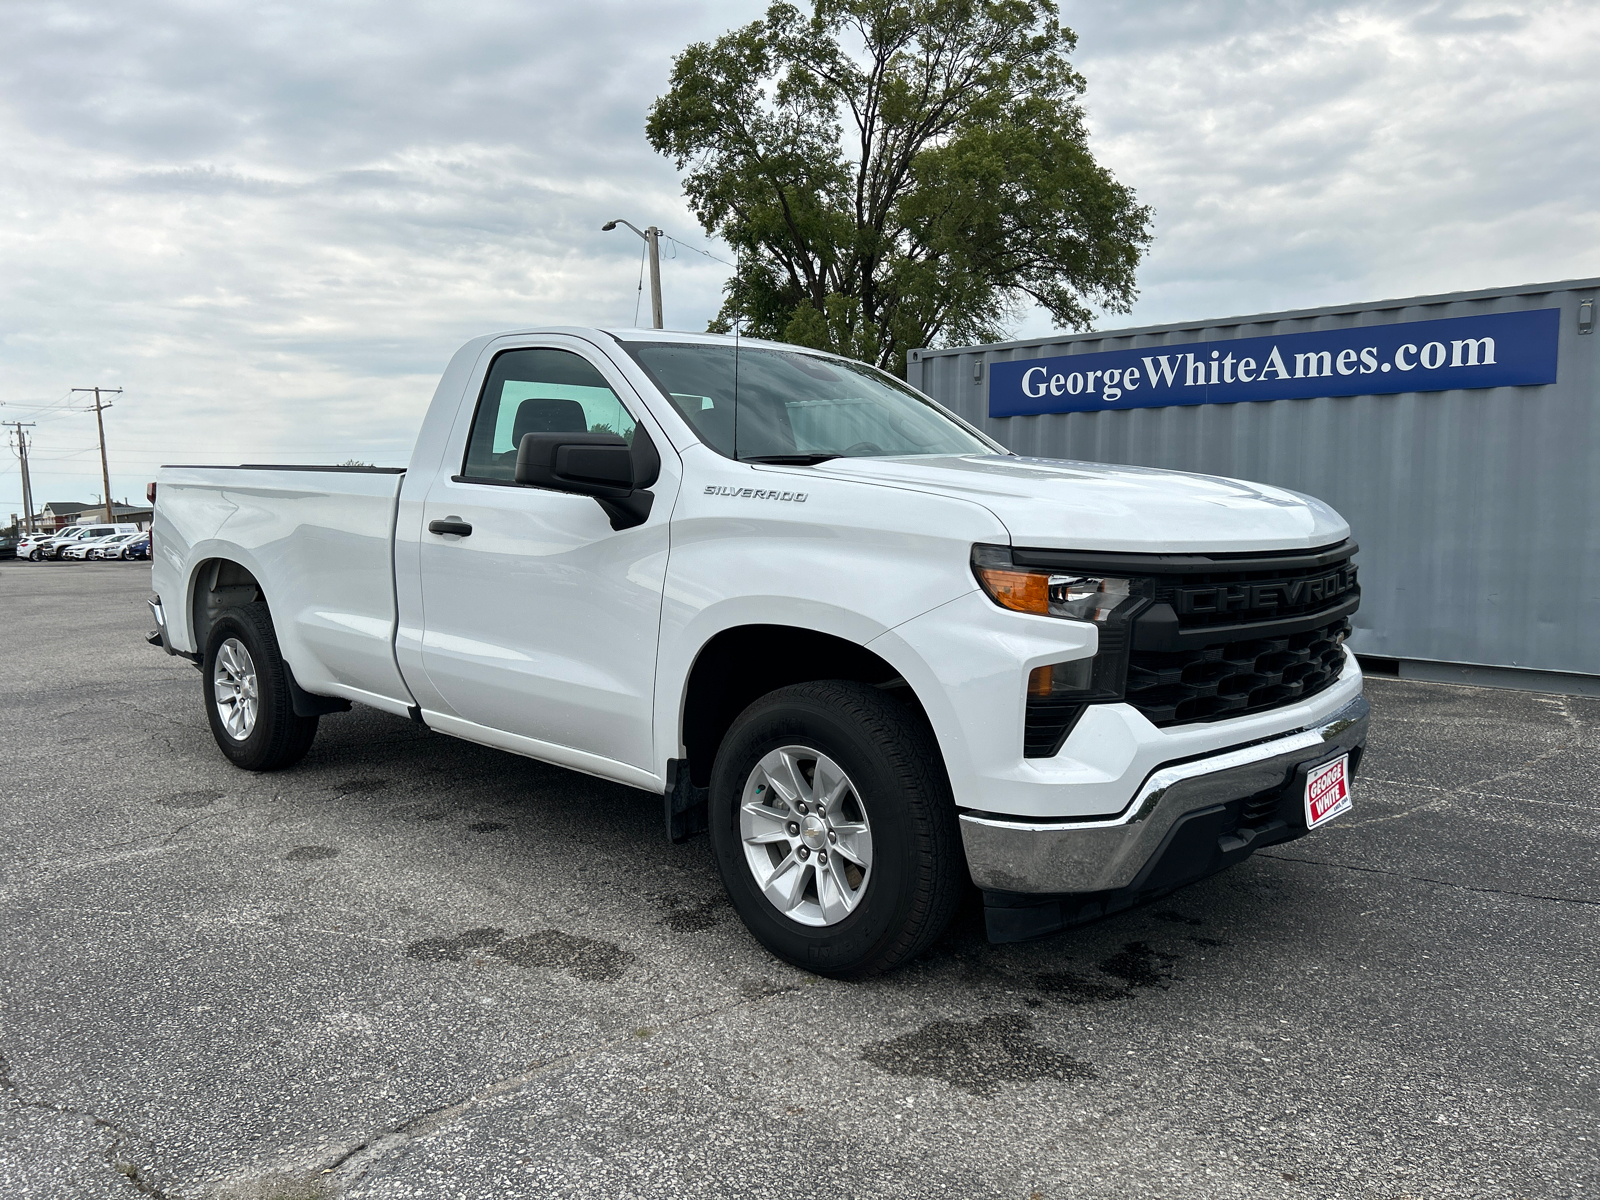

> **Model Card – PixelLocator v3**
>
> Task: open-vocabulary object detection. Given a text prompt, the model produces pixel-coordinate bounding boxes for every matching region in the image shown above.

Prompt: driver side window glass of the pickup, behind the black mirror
[461,349,638,483]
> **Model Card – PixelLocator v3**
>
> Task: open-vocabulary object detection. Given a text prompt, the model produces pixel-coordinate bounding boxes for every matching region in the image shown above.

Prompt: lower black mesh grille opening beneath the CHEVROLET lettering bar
[1126,616,1350,725]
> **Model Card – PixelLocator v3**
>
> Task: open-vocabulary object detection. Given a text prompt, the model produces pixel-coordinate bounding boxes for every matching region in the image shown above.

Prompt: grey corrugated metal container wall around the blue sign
[907,280,1600,675]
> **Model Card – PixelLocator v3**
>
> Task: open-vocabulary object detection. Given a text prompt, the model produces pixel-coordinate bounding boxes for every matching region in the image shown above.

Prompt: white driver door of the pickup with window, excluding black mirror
[418,346,678,773]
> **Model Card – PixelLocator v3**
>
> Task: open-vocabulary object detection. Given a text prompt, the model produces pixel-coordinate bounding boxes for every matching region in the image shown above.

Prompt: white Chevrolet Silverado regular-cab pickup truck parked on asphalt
[150,328,1368,976]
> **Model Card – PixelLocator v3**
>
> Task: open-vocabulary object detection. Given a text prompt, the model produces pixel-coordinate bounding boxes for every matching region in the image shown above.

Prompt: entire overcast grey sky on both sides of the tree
[0,0,1600,508]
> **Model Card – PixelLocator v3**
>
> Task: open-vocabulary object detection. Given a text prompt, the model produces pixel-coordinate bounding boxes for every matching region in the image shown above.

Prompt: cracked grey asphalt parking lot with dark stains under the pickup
[0,563,1600,1200]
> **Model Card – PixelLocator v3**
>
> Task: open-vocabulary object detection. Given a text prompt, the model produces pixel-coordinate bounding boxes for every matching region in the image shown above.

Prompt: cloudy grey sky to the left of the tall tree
[0,3,747,499]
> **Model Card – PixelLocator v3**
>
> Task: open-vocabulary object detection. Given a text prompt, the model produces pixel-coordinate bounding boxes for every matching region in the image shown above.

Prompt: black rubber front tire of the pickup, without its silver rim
[710,680,966,978]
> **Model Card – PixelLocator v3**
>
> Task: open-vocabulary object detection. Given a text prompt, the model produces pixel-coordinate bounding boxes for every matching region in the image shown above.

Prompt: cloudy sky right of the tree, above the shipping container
[1032,2,1600,333]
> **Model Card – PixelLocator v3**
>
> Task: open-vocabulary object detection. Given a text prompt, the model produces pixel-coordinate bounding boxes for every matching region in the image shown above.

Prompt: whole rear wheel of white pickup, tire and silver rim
[202,602,317,771]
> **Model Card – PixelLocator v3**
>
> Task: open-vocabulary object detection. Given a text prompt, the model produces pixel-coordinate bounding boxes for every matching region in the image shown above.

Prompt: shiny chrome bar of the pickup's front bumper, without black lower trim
[962,696,1371,893]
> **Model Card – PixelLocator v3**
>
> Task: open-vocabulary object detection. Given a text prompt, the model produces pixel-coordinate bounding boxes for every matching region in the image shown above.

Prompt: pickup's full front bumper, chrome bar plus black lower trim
[962,696,1370,941]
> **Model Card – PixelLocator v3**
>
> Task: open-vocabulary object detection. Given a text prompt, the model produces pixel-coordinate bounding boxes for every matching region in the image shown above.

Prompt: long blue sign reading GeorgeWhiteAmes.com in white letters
[989,309,1562,416]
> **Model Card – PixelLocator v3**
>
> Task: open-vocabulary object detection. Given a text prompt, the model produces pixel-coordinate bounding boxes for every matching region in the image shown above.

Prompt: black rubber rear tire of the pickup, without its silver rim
[200,600,317,771]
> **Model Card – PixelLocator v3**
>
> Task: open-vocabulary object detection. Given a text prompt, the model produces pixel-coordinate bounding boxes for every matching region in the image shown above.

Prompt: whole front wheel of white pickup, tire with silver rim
[710,680,965,978]
